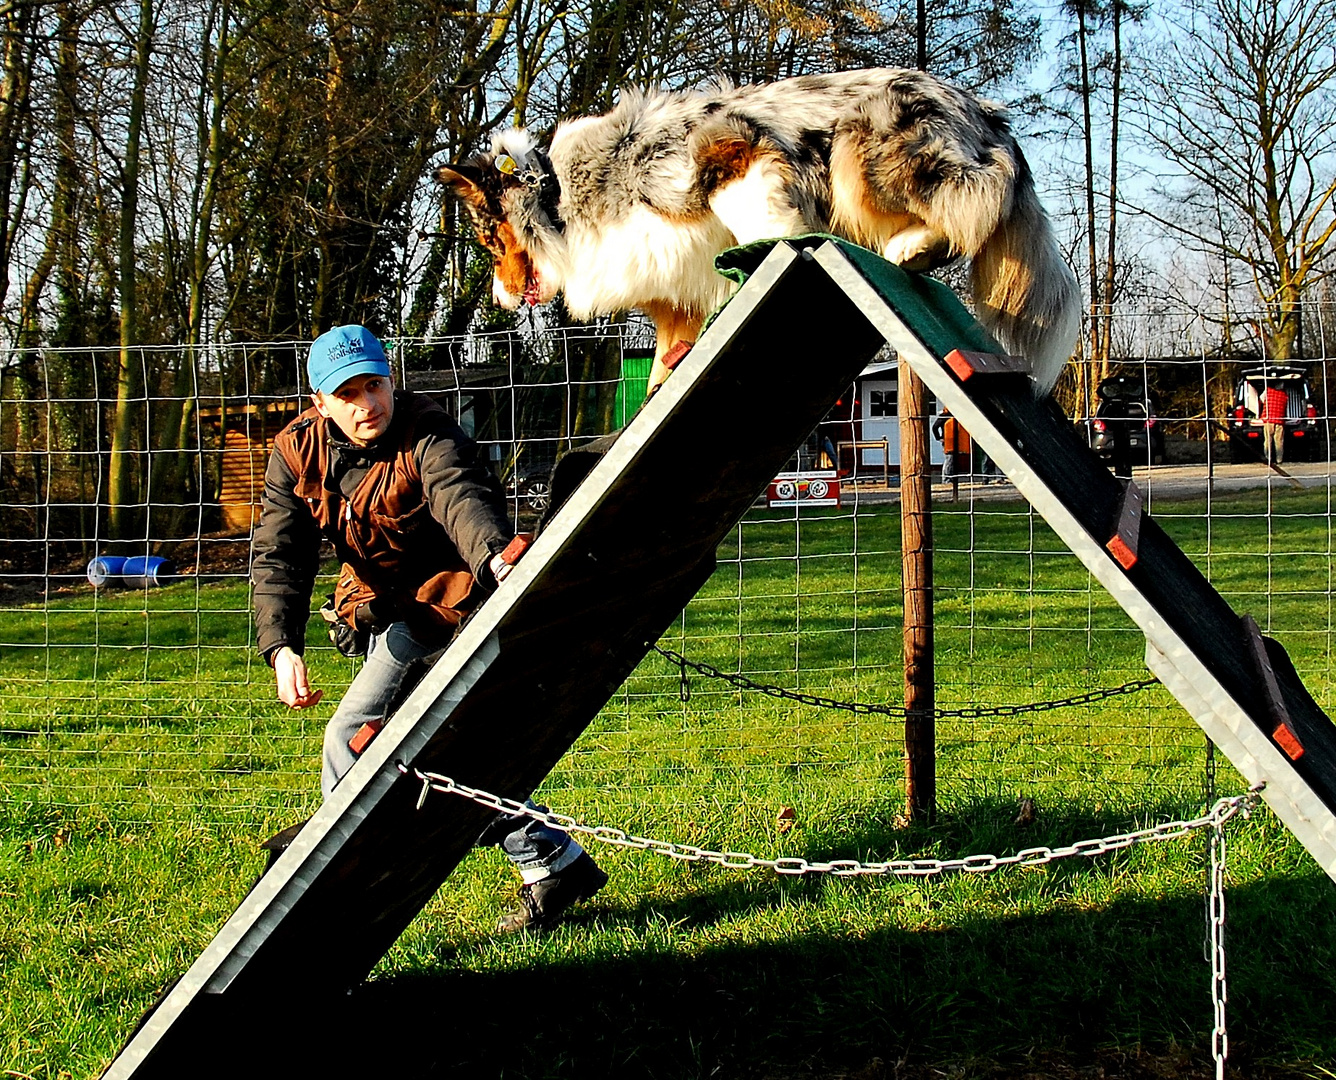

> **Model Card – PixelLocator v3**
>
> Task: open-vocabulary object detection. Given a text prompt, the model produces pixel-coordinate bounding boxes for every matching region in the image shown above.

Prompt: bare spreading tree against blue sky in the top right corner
[1138,0,1336,360]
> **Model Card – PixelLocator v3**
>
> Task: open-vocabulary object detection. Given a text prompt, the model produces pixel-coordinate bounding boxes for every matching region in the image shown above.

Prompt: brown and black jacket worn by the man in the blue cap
[251,390,512,659]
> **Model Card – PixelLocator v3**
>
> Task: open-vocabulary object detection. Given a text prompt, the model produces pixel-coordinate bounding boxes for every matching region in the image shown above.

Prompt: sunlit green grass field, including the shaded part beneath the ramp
[0,491,1336,1080]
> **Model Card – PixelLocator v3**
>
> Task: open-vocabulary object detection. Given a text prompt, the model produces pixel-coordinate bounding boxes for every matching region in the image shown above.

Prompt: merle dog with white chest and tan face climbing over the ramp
[436,68,1081,392]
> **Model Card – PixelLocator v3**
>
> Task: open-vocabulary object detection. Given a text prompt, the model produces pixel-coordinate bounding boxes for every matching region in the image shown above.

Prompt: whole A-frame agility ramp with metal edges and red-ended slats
[106,238,1336,1080]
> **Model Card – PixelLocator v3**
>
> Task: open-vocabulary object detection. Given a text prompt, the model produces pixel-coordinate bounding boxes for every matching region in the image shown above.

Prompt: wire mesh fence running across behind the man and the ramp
[0,317,1333,823]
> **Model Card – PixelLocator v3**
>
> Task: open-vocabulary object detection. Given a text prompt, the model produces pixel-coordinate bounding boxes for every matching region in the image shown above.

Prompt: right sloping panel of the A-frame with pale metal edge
[815,242,1336,880]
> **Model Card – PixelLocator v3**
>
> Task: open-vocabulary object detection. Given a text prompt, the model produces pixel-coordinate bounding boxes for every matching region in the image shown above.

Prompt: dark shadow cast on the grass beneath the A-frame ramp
[309,803,1336,1077]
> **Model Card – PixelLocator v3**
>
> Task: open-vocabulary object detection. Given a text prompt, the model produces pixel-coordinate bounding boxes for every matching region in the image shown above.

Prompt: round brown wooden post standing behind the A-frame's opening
[899,360,937,822]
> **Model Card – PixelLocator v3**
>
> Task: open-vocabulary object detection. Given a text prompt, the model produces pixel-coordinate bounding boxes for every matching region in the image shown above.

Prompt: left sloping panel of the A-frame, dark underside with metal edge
[107,245,883,1080]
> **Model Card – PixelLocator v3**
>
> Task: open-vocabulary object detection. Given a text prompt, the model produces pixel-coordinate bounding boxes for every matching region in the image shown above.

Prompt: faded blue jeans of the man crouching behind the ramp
[321,623,584,884]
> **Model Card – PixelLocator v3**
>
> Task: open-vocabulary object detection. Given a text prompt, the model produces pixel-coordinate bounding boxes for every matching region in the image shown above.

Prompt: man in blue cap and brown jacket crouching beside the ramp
[251,325,608,932]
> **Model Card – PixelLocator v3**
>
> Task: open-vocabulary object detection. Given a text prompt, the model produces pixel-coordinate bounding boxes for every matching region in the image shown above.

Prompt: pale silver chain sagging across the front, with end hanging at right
[397,762,1267,1080]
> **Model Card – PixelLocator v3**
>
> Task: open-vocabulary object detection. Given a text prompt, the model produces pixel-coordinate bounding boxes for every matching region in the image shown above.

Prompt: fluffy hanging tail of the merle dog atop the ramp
[970,160,1081,393]
